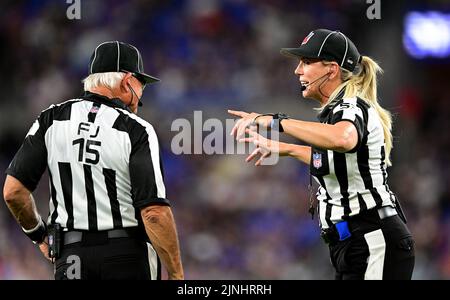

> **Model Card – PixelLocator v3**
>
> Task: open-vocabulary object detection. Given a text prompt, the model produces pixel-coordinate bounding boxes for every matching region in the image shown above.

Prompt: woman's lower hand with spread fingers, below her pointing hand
[239,129,280,166]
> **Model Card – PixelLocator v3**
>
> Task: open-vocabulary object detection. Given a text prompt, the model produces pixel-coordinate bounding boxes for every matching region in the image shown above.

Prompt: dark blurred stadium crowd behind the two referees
[0,0,450,279]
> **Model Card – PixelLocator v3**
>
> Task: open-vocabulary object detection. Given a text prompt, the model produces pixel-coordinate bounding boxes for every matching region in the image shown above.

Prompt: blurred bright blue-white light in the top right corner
[403,11,450,59]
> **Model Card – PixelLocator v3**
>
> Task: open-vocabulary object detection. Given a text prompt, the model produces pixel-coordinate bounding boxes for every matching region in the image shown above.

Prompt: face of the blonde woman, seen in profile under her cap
[294,57,330,100]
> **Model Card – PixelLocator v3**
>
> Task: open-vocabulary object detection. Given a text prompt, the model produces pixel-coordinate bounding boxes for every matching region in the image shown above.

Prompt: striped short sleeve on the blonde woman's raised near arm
[331,98,366,153]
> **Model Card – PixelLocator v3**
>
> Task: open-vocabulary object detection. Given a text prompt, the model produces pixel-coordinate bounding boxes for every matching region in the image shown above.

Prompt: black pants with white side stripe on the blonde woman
[330,213,414,280]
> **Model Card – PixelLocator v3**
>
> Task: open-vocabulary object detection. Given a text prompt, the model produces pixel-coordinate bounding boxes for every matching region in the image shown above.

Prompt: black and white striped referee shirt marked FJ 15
[6,92,169,231]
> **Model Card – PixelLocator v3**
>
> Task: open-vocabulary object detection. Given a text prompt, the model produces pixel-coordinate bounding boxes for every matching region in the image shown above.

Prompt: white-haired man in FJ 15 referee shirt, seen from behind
[3,41,184,279]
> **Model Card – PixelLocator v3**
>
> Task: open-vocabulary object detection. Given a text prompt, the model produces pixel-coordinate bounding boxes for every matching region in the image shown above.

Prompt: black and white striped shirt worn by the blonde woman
[310,92,395,228]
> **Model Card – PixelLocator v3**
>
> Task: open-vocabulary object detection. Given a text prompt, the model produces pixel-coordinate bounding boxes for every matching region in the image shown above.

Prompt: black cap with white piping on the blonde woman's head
[280,29,361,72]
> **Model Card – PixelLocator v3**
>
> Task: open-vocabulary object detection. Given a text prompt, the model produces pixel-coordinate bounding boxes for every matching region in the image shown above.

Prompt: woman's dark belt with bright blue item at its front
[320,206,397,244]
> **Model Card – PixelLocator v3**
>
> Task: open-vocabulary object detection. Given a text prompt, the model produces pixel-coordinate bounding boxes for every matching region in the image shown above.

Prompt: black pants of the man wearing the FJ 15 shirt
[55,238,161,280]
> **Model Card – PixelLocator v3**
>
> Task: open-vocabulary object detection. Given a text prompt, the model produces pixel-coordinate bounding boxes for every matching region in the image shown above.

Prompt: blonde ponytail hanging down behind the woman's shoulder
[324,56,393,166]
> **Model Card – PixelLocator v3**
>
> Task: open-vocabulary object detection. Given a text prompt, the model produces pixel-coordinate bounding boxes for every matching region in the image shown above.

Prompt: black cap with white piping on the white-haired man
[89,41,160,85]
